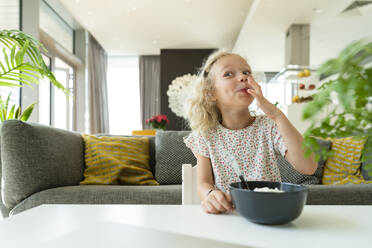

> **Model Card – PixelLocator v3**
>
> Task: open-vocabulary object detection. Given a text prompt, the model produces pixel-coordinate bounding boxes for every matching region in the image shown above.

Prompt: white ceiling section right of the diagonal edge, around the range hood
[233,0,372,71]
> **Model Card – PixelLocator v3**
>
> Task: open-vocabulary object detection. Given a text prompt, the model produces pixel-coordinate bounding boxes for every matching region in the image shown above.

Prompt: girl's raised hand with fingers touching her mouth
[247,75,280,119]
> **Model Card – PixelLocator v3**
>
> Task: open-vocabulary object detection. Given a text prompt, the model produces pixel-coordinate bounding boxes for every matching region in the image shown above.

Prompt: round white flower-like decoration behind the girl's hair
[167,73,197,118]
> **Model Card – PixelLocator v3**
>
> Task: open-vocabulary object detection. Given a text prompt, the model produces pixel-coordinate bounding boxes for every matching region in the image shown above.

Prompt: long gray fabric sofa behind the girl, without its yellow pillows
[0,120,372,217]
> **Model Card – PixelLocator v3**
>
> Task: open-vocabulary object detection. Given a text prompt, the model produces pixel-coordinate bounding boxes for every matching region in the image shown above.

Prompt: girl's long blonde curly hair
[185,50,240,135]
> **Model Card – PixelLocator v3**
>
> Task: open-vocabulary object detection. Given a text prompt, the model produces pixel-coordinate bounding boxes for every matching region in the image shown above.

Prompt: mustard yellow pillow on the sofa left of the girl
[80,134,159,185]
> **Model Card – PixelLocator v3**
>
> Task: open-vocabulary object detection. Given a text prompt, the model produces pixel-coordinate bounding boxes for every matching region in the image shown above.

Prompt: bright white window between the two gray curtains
[107,57,142,135]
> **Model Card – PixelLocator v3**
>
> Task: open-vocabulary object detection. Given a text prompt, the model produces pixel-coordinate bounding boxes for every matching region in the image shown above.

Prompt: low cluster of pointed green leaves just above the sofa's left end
[0,93,36,123]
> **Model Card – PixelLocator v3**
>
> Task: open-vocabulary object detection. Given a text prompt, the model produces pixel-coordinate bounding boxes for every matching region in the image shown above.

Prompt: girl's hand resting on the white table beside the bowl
[201,189,234,214]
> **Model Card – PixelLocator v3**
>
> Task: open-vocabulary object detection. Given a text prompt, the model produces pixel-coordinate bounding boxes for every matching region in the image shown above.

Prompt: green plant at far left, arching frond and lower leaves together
[0,30,70,121]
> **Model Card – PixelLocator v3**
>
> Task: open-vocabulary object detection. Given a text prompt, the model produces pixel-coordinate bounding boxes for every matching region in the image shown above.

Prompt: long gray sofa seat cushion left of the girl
[10,185,182,215]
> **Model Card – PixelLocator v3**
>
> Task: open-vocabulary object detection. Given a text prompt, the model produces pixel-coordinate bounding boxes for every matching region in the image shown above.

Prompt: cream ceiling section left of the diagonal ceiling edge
[60,0,253,55]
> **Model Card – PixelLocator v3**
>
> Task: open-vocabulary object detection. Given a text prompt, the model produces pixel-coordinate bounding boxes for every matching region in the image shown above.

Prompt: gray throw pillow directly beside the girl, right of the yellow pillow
[155,131,196,184]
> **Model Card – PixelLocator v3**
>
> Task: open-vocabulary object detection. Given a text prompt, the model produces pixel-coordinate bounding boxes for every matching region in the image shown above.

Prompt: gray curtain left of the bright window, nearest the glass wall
[88,34,110,133]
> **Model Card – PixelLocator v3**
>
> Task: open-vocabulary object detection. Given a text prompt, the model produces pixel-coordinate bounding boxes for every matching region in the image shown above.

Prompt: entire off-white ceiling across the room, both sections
[56,0,372,71]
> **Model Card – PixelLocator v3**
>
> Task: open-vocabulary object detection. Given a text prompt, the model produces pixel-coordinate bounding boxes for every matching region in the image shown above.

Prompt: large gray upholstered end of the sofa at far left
[1,120,84,209]
